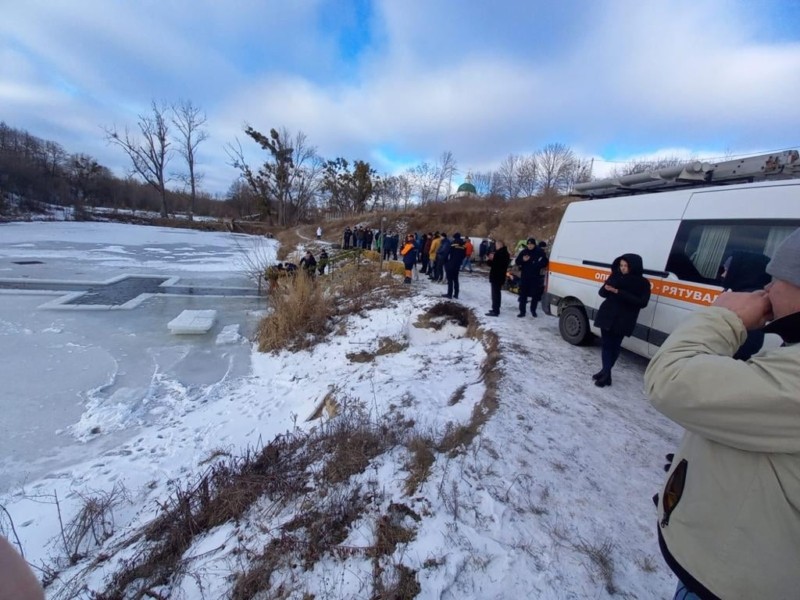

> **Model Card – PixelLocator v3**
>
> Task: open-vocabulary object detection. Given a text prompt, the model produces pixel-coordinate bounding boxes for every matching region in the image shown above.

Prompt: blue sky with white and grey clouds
[0,0,800,193]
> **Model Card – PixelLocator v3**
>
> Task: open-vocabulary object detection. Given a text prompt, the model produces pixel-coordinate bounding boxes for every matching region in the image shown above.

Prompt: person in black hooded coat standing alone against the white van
[592,254,650,387]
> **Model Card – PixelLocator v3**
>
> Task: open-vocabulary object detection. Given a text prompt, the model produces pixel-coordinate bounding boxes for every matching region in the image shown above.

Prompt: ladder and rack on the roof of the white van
[570,150,800,198]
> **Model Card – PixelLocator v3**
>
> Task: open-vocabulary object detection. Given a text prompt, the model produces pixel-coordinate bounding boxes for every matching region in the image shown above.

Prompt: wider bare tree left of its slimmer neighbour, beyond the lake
[104,100,172,218]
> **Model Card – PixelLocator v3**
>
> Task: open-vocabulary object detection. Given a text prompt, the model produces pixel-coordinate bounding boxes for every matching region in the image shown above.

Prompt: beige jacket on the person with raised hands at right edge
[644,307,800,600]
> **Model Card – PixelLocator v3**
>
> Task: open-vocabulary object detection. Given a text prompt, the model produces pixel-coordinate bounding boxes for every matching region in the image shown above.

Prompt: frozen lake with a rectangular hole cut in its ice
[0,223,272,492]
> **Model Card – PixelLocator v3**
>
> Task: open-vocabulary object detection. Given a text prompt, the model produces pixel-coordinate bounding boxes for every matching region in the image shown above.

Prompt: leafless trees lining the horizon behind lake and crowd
[0,100,692,226]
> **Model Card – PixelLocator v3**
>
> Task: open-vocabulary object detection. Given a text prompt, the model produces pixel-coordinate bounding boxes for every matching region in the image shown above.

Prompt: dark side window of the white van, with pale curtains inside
[664,220,800,285]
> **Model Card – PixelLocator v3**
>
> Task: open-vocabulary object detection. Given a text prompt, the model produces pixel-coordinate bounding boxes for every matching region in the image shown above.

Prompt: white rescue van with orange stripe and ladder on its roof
[542,152,800,356]
